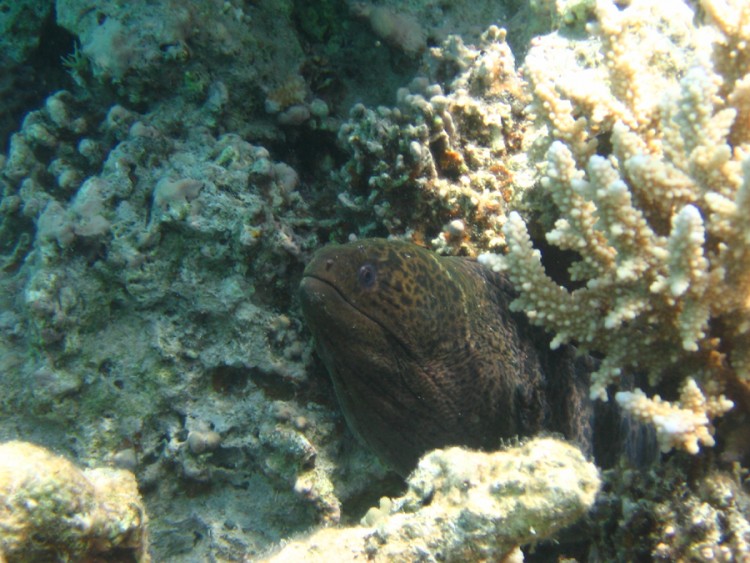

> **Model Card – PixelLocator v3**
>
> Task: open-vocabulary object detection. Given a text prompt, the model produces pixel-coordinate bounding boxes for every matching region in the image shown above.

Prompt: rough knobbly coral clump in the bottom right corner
[589,454,750,561]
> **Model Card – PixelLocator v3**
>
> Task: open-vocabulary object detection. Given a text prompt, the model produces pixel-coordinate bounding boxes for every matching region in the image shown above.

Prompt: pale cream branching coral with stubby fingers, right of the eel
[485,0,750,453]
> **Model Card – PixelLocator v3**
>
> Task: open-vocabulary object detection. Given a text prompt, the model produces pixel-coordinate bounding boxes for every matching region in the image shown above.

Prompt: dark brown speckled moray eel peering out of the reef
[300,239,591,475]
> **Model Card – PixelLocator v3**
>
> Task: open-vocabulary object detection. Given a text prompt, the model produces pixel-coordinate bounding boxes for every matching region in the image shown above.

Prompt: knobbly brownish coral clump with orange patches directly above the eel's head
[338,27,533,254]
